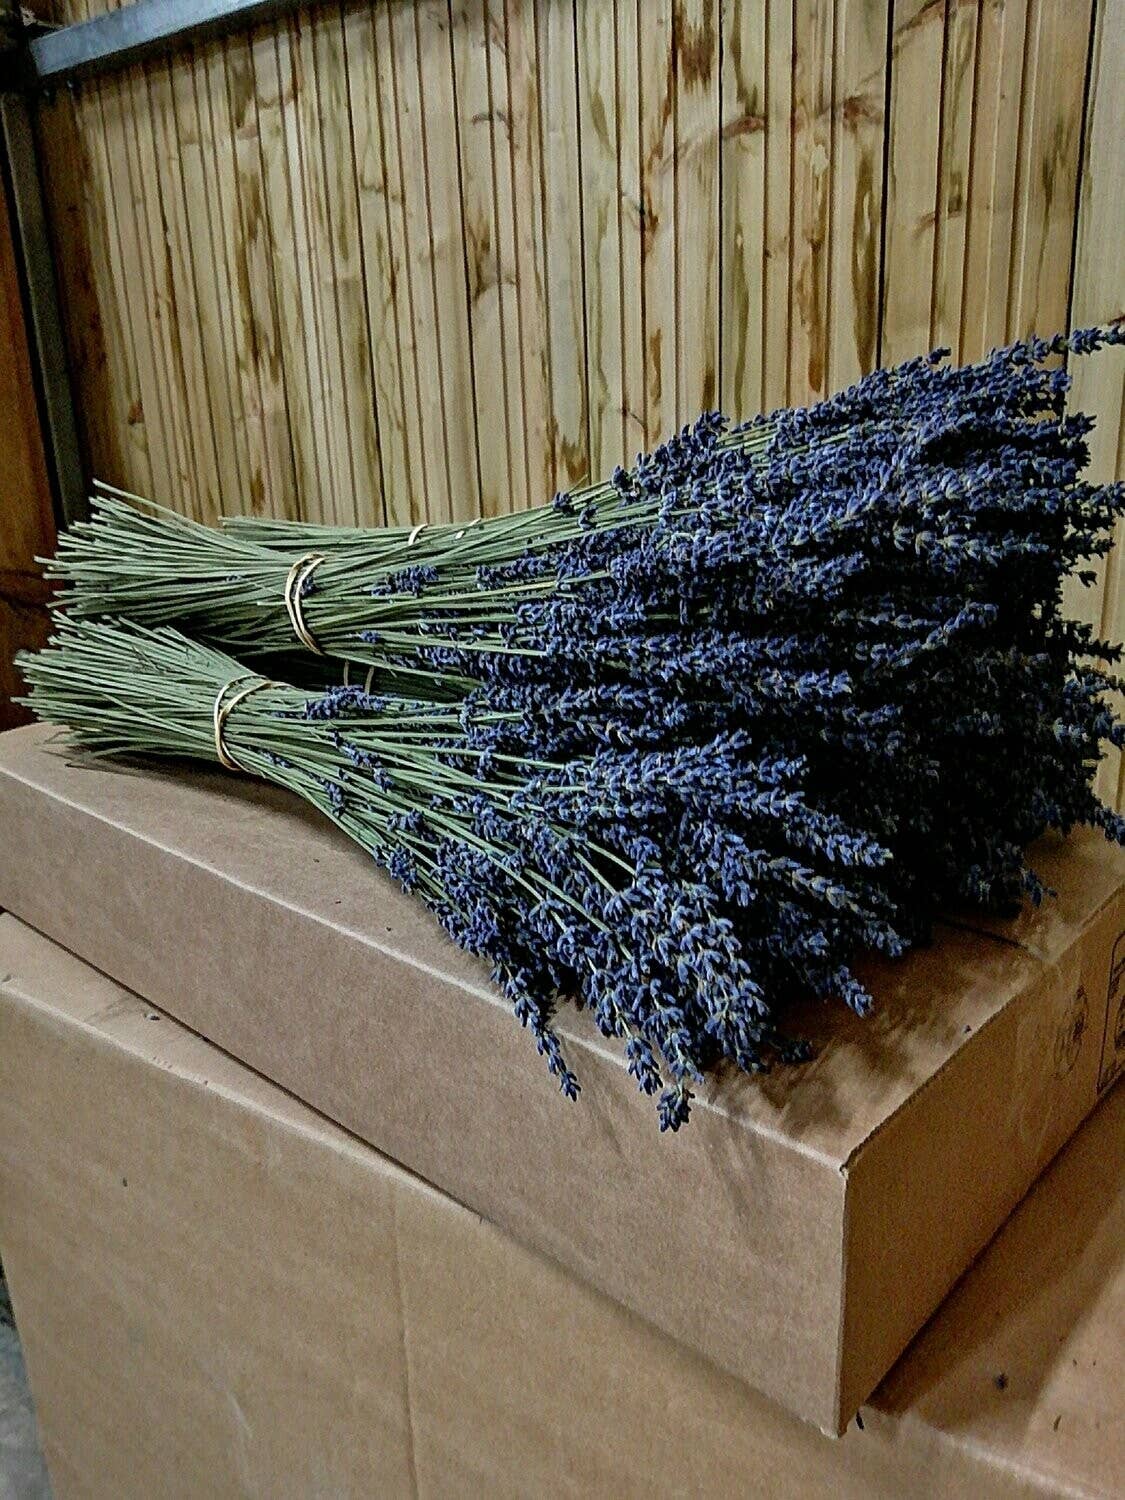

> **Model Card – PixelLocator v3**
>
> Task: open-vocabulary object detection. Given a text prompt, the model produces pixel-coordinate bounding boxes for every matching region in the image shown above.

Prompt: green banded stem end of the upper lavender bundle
[48,422,770,683]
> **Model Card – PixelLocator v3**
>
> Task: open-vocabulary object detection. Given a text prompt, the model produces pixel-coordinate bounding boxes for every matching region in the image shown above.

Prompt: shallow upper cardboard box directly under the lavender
[0,728,1125,1431]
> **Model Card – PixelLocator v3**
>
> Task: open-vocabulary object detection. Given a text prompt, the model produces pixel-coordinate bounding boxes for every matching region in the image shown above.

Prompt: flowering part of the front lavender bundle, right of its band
[290,675,903,1128]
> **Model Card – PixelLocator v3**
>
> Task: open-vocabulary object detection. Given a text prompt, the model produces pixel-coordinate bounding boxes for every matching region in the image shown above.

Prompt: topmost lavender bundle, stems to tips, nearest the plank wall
[50,329,1122,677]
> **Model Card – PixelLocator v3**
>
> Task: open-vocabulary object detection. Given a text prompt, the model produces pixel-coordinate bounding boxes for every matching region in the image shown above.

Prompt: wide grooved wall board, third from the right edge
[720,0,890,413]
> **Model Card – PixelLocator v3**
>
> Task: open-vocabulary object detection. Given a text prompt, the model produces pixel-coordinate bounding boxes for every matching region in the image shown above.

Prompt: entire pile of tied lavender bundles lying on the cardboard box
[23,329,1125,1130]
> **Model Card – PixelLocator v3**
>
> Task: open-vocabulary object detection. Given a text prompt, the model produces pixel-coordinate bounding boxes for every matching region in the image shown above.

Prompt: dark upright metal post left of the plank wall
[0,0,87,524]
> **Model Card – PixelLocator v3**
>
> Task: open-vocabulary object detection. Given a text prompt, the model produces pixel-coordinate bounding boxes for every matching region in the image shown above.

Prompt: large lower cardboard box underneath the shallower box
[0,917,1125,1500]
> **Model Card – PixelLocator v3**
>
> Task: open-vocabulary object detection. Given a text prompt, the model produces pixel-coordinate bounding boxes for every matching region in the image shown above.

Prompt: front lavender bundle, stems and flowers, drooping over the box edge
[21,621,903,1130]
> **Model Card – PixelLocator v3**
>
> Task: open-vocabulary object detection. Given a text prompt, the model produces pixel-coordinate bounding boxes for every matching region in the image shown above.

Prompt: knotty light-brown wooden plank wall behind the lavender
[35,0,1125,555]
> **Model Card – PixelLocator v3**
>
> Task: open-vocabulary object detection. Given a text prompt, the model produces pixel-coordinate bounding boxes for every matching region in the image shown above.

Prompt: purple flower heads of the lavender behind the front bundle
[401,330,1125,938]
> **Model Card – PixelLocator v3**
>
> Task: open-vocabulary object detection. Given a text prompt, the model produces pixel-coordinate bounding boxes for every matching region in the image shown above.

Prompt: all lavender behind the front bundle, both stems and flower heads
[41,329,1125,938]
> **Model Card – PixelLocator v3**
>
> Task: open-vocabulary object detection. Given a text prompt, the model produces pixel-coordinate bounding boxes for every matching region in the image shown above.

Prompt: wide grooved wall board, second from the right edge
[881,0,1092,363]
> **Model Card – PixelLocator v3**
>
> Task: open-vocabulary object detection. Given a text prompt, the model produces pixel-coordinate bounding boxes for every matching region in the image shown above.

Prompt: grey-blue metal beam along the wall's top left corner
[27,0,308,84]
